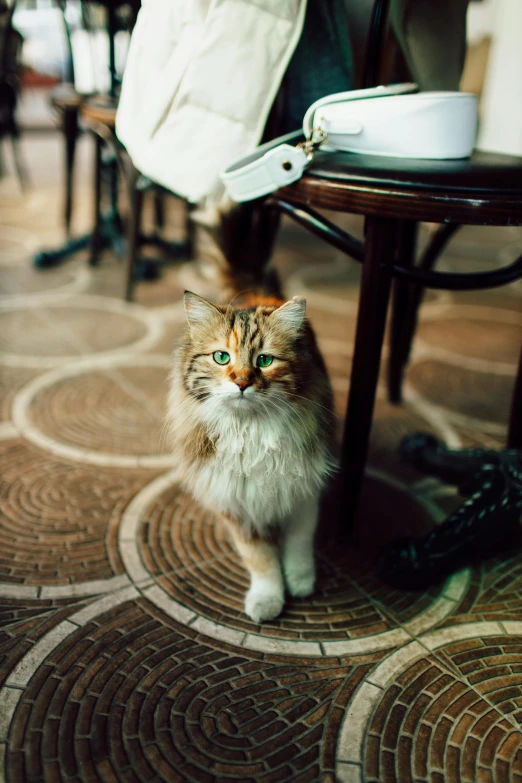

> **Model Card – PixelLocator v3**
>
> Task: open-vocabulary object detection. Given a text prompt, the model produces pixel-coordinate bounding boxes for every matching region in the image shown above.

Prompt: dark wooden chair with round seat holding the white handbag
[267,0,522,533]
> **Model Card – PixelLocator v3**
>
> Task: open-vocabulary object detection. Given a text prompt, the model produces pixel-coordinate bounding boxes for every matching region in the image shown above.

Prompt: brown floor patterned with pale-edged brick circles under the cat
[0,135,522,783]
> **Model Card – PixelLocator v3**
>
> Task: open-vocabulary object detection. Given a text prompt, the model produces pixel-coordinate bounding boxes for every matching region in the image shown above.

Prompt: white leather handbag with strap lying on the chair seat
[221,84,477,202]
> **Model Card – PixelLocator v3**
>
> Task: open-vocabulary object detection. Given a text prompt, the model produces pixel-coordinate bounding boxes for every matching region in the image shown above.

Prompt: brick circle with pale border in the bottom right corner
[337,623,522,783]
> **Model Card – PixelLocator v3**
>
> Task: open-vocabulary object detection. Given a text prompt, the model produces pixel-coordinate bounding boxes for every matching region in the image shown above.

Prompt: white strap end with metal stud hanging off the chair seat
[221,131,309,202]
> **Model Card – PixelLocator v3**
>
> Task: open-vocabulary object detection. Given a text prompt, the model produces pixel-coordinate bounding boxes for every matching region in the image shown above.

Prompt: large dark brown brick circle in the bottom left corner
[4,600,351,783]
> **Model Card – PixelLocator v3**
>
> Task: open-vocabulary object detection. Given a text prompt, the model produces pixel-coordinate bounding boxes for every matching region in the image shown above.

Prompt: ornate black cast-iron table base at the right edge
[376,433,522,589]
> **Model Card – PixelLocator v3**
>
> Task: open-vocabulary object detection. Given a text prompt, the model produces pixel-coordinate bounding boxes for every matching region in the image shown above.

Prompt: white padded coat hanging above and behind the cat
[116,0,306,206]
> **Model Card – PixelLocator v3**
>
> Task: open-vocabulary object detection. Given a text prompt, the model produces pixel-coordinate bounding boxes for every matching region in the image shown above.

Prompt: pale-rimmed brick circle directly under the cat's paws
[119,473,467,656]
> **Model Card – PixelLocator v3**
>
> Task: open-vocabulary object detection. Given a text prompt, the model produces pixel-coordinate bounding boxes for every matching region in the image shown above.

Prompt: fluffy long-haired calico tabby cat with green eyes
[168,292,334,622]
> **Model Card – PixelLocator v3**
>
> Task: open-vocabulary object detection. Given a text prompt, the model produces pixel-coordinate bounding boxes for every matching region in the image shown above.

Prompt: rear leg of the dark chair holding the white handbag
[388,220,418,404]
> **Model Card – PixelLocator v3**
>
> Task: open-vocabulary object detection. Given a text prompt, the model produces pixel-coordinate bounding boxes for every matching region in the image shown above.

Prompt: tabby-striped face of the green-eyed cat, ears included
[184,292,306,413]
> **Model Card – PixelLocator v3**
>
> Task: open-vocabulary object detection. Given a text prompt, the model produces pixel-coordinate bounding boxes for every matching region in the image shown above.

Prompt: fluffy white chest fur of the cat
[192,404,330,532]
